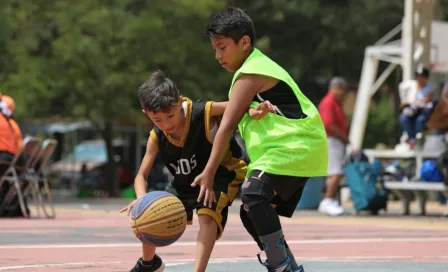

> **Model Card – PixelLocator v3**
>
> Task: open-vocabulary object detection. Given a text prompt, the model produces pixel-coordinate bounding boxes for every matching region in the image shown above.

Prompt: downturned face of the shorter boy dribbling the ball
[143,102,185,134]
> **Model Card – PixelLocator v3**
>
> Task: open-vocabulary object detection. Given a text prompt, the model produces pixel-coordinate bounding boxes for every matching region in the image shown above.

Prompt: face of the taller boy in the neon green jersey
[210,35,250,72]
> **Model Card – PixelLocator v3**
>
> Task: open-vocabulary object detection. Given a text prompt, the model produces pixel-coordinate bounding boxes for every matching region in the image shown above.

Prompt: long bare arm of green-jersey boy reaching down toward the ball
[191,75,264,207]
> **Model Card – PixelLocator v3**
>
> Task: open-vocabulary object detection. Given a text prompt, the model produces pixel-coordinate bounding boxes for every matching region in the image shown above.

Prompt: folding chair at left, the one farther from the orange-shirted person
[25,139,58,218]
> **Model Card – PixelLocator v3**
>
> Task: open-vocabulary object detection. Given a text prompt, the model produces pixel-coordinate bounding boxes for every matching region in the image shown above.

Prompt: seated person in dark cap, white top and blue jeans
[399,66,434,149]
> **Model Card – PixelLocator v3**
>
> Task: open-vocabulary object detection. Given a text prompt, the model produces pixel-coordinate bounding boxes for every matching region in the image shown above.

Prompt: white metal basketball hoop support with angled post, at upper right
[349,0,433,151]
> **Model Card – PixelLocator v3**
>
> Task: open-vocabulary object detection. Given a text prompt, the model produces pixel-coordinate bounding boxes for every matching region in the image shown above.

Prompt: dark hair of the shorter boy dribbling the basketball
[138,70,180,112]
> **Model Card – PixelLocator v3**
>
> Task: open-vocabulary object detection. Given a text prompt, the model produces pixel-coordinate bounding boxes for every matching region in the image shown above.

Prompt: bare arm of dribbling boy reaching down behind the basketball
[120,134,159,215]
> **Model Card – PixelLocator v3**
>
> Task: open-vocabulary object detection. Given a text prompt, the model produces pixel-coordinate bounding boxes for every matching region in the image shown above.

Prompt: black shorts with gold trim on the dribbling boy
[165,175,244,240]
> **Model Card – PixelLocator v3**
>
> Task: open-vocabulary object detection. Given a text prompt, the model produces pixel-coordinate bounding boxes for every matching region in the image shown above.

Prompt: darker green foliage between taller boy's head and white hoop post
[229,0,404,103]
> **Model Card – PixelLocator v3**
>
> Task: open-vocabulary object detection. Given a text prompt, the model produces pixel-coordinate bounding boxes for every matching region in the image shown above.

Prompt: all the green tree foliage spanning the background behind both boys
[0,0,448,194]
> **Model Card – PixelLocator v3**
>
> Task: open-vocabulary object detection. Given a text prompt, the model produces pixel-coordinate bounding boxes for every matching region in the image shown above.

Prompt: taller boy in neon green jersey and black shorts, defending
[192,8,328,272]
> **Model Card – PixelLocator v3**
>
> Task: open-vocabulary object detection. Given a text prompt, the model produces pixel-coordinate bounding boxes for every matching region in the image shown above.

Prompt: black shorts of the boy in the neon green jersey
[241,170,309,217]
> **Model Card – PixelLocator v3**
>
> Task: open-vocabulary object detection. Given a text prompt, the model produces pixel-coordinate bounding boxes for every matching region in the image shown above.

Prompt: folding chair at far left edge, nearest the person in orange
[0,137,41,218]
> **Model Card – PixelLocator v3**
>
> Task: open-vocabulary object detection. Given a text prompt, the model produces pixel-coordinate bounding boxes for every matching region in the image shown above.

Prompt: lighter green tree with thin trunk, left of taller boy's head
[0,0,228,194]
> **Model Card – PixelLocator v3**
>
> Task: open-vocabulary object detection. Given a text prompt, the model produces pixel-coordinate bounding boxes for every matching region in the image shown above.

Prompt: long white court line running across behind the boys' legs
[0,237,448,249]
